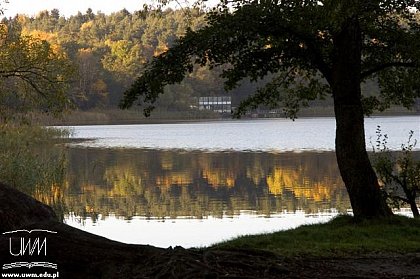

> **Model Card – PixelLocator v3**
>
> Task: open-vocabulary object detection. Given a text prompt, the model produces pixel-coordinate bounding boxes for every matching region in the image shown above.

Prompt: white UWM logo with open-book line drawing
[3,229,57,269]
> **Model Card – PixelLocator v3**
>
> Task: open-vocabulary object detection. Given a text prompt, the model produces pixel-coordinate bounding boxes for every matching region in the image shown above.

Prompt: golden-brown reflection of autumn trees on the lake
[64,148,350,221]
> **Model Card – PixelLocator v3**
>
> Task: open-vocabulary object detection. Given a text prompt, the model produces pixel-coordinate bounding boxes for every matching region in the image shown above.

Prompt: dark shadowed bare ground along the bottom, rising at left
[0,184,420,278]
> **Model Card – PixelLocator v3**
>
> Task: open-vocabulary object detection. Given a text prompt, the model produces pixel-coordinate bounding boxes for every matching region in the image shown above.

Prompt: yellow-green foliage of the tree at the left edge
[0,24,74,117]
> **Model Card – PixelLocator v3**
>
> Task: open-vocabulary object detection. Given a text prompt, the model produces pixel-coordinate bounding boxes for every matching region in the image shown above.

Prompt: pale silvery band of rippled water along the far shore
[67,116,420,152]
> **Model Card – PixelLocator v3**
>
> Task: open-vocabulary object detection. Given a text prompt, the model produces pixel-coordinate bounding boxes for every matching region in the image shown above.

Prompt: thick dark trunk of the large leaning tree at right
[332,19,392,218]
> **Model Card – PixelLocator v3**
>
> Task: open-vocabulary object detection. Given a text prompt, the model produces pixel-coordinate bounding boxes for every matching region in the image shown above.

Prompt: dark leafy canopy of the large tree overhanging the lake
[120,0,420,116]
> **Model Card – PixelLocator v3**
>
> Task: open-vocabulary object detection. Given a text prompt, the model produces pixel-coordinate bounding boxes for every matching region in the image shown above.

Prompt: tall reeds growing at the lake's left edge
[0,124,69,221]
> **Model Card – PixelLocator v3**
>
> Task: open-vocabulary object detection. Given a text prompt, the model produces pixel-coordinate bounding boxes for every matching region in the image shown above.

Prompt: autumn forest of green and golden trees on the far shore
[0,9,270,116]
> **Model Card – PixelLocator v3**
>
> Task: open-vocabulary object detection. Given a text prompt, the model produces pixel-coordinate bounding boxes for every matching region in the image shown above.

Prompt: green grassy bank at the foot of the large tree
[214,216,420,257]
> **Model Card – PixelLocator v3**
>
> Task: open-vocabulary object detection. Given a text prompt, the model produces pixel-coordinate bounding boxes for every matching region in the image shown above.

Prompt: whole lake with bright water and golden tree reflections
[58,116,420,247]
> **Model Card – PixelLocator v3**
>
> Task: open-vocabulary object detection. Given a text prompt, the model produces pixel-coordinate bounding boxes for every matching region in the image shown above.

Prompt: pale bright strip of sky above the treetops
[2,0,153,17]
